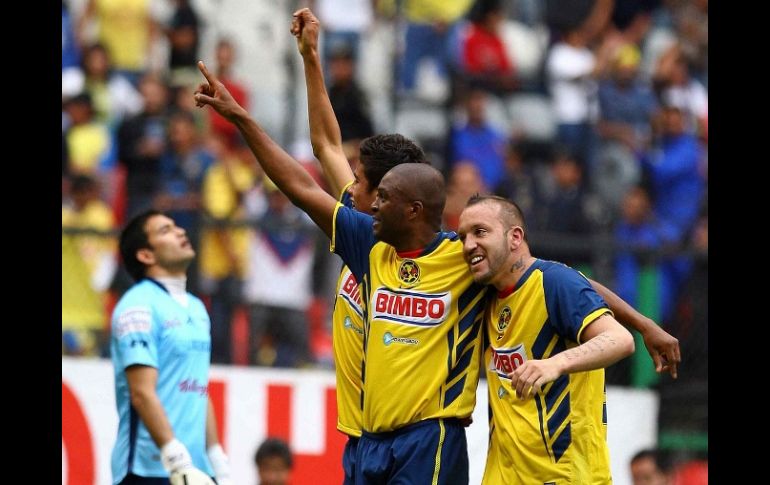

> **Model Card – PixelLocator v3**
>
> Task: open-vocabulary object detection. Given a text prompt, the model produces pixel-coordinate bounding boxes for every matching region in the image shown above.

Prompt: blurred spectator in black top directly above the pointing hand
[166,0,200,86]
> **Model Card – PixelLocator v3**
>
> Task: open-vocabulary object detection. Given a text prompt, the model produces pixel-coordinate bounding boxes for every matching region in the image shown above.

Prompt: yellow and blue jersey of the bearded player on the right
[482,260,612,485]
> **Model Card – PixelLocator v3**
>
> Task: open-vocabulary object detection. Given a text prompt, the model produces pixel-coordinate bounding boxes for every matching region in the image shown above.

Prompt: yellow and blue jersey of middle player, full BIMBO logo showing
[332,204,486,433]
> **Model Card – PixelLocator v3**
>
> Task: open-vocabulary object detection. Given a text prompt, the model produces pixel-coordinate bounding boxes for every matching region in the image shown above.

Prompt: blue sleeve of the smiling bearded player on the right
[543,262,608,342]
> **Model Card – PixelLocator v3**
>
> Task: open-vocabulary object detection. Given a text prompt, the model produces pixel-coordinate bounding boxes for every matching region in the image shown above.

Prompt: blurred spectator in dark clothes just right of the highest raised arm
[328,47,374,142]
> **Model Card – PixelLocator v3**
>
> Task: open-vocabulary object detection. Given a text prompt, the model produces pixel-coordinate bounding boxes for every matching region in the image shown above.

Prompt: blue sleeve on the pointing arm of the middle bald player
[334,207,377,282]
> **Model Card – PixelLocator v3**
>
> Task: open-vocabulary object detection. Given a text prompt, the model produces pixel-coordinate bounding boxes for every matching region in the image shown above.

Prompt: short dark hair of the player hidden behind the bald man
[359,134,429,190]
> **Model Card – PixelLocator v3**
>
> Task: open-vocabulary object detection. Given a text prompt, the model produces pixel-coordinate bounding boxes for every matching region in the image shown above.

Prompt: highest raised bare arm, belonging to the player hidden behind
[291,8,353,197]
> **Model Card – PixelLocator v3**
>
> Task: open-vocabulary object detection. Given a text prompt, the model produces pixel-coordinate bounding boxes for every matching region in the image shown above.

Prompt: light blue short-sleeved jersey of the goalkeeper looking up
[110,279,213,484]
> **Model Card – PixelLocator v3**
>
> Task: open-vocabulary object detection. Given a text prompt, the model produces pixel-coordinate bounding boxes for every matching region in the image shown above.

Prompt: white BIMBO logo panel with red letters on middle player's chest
[371,287,452,326]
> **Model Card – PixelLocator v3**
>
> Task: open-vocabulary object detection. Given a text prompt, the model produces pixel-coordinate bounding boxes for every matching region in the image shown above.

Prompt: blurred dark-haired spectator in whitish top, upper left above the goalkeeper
[83,44,142,128]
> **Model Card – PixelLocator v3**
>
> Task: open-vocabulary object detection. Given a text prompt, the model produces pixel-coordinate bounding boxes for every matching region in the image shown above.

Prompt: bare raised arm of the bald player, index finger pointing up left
[195,61,337,237]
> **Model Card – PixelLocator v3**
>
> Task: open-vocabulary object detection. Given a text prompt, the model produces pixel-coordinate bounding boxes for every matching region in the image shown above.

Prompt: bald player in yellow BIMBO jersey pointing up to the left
[195,58,485,485]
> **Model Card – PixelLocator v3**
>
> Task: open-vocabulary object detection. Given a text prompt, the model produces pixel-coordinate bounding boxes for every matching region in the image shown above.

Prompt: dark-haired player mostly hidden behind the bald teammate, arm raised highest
[291,9,427,484]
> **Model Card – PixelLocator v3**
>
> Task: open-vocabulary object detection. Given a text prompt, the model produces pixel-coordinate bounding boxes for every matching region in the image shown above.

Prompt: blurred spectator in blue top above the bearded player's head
[448,88,506,188]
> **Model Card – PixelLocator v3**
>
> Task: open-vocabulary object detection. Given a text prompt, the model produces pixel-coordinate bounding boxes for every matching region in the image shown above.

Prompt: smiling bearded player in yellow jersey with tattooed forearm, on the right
[458,195,634,485]
